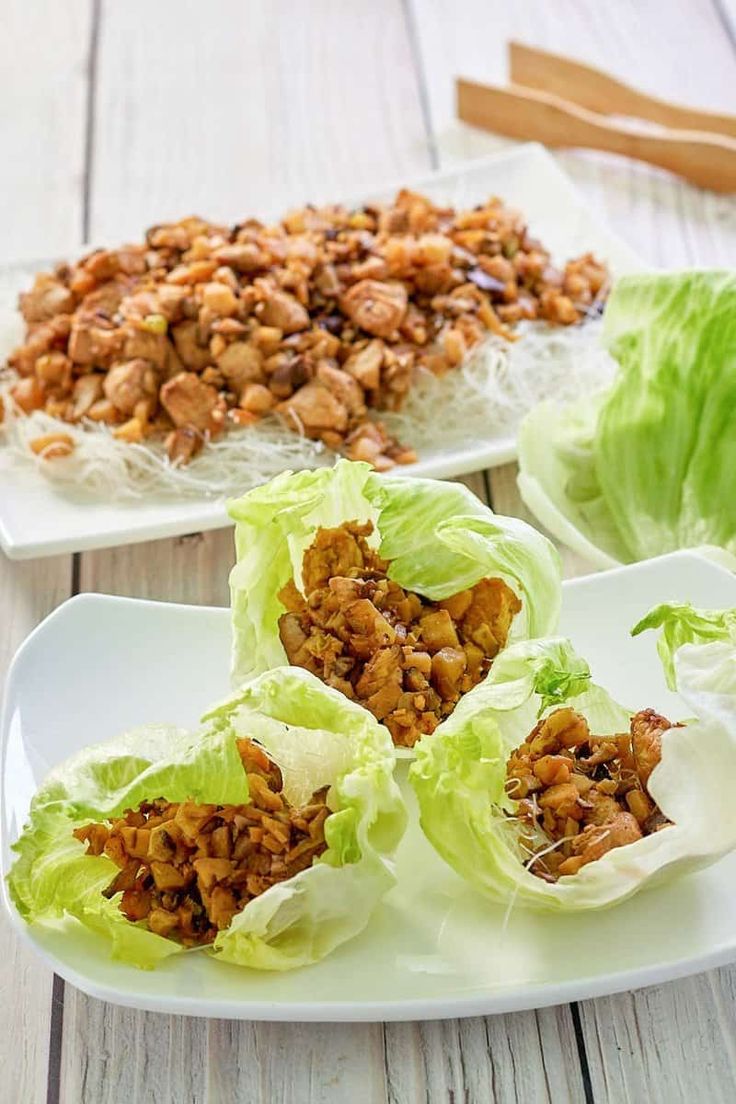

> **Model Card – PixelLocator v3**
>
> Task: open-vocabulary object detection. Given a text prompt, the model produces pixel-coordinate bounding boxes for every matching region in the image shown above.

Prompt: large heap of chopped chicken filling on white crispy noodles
[9,190,608,469]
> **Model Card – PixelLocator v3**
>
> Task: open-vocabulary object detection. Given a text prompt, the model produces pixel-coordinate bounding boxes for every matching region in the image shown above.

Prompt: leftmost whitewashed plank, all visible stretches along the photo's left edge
[0,0,90,1102]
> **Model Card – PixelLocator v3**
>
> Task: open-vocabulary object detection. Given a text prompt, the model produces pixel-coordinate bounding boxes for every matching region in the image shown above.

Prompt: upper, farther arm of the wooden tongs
[509,42,736,139]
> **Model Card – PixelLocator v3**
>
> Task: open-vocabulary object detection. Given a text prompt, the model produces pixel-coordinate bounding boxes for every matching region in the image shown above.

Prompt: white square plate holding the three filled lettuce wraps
[2,552,736,1021]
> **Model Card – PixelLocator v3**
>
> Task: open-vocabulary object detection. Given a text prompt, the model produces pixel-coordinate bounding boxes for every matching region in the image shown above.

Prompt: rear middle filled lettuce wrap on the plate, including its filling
[228,460,561,747]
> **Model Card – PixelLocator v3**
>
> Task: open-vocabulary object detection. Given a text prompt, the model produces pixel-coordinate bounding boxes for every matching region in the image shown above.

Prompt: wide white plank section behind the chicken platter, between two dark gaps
[92,0,428,238]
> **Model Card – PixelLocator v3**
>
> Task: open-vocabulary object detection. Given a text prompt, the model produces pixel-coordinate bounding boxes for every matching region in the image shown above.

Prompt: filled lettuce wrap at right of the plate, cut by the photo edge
[409,606,736,910]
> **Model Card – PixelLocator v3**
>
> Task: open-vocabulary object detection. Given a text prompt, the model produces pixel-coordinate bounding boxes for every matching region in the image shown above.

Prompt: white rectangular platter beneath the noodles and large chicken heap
[0,145,642,560]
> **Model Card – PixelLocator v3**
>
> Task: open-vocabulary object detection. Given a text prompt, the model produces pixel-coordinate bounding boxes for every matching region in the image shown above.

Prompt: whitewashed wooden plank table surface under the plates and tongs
[0,0,736,1104]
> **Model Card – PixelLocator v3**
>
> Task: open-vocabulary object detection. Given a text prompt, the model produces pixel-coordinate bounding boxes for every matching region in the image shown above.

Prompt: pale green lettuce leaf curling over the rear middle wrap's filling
[228,460,561,684]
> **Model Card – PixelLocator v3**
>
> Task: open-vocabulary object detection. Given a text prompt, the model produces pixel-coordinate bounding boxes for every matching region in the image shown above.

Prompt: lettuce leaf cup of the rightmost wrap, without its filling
[409,607,736,912]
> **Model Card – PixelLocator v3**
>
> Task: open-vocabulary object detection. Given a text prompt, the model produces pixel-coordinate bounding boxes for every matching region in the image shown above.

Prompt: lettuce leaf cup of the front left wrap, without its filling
[8,668,406,969]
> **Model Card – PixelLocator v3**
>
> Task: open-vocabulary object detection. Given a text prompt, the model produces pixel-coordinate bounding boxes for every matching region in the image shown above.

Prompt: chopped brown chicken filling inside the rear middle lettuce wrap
[278,521,521,747]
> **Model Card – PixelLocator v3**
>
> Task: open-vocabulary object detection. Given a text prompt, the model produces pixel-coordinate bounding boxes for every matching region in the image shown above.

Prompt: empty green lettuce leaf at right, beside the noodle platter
[519,272,736,566]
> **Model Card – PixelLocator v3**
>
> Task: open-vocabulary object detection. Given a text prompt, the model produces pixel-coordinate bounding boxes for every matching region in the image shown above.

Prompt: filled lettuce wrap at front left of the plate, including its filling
[8,668,405,970]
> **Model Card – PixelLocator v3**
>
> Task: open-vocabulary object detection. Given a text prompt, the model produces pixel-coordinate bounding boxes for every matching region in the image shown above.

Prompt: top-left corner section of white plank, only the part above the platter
[0,0,92,261]
